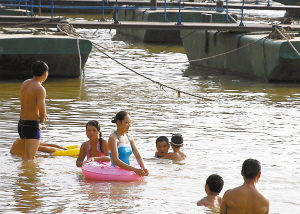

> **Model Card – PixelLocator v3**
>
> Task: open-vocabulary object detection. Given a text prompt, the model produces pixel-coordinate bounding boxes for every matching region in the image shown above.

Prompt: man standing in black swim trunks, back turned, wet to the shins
[18,61,48,160]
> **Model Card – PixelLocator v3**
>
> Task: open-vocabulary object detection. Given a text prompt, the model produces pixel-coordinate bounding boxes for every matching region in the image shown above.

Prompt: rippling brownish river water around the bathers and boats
[0,0,300,214]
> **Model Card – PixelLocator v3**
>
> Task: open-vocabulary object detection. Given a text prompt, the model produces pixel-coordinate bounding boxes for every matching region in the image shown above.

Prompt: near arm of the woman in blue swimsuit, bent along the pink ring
[108,136,145,176]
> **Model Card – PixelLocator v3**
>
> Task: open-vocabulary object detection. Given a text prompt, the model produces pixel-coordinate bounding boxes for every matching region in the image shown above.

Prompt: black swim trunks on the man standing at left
[18,119,41,140]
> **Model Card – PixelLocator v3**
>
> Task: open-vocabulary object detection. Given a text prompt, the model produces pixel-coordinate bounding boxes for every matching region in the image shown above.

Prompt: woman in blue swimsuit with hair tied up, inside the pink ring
[108,111,148,176]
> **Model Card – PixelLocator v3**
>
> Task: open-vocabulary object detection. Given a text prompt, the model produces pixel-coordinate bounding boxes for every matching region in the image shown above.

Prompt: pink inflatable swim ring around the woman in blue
[81,161,144,181]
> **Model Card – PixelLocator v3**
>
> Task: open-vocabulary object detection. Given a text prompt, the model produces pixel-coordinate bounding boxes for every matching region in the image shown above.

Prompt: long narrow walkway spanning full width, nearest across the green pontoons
[0,16,300,32]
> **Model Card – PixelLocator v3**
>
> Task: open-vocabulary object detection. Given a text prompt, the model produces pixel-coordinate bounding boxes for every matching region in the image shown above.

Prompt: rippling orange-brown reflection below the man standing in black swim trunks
[14,160,43,213]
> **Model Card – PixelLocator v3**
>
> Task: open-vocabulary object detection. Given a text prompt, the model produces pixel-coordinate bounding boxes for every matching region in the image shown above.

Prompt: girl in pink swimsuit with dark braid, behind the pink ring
[76,120,110,167]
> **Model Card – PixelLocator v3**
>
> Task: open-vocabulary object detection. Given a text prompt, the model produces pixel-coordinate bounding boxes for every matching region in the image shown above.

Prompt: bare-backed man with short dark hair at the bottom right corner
[220,159,270,214]
